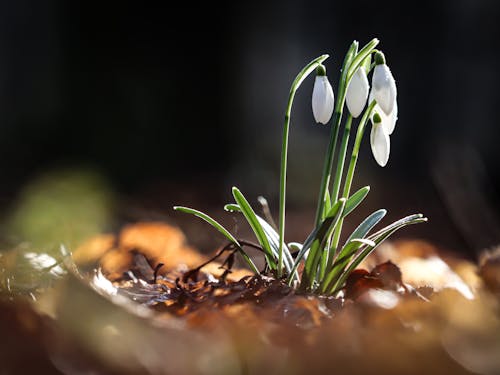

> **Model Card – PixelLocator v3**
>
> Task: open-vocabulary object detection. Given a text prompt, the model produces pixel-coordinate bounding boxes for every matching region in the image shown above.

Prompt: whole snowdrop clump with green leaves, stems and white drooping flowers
[174,39,427,295]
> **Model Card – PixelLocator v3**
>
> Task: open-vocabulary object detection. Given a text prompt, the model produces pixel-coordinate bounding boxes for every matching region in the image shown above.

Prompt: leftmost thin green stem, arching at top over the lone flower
[277,55,328,278]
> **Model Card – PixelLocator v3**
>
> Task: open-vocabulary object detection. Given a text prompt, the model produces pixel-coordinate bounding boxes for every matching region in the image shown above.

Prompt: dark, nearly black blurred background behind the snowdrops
[0,0,500,256]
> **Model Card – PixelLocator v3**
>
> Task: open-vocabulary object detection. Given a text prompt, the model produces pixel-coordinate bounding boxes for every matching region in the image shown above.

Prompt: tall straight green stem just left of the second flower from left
[314,41,358,227]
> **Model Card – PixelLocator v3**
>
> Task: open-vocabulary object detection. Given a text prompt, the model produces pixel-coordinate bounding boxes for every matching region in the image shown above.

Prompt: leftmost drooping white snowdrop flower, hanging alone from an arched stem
[312,65,335,124]
